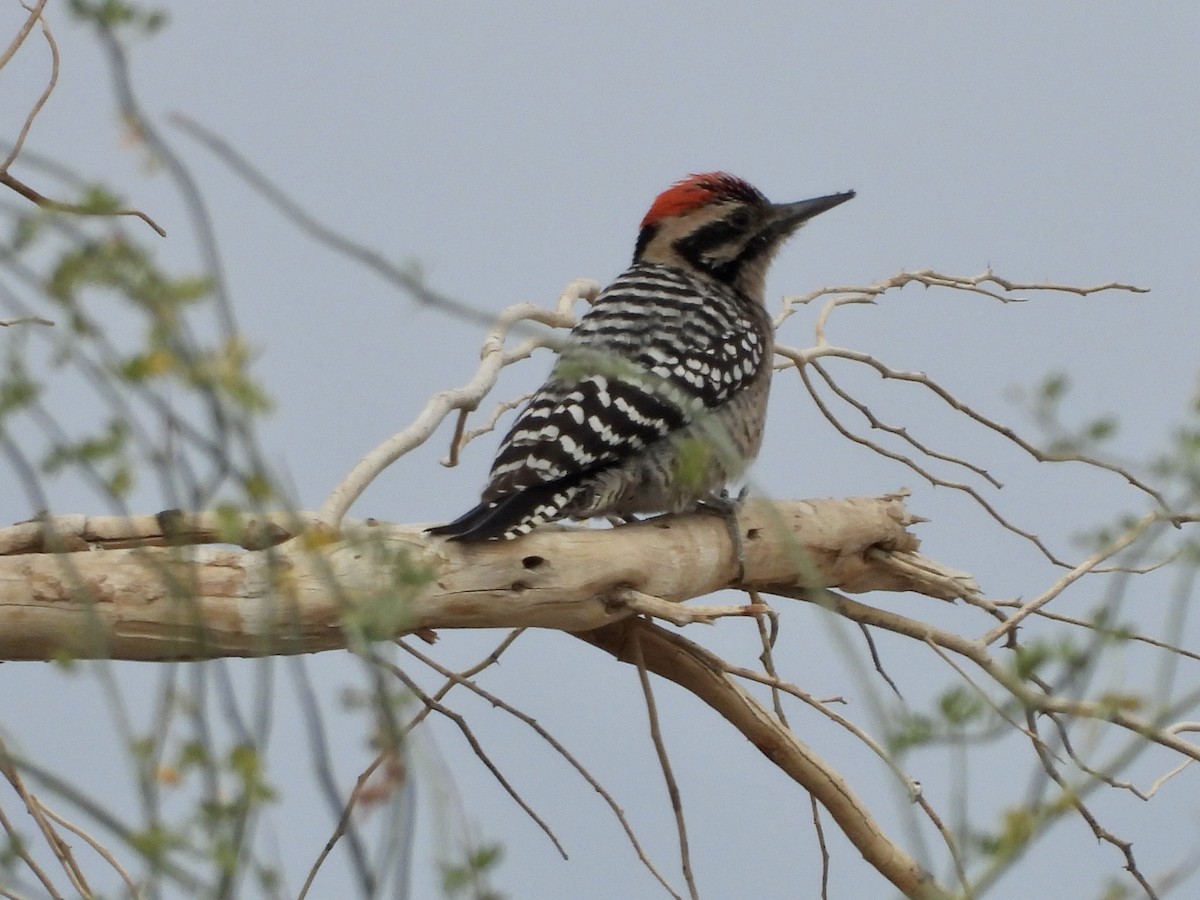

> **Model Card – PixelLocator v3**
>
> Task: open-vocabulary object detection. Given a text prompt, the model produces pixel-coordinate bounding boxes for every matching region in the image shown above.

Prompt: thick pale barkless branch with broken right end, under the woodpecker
[0,497,971,660]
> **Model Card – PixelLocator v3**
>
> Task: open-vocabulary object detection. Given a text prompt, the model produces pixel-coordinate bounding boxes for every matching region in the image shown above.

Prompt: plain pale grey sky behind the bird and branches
[0,0,1200,898]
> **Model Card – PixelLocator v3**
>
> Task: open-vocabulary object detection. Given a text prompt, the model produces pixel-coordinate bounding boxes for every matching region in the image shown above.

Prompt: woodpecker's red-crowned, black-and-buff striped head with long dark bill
[634,172,854,300]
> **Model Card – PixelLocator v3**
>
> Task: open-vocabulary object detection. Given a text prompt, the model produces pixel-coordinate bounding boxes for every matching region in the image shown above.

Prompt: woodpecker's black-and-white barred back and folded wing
[482,269,766,502]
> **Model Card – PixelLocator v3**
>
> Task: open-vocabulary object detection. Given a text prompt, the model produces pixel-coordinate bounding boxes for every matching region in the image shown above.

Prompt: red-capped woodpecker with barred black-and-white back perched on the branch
[428,172,854,541]
